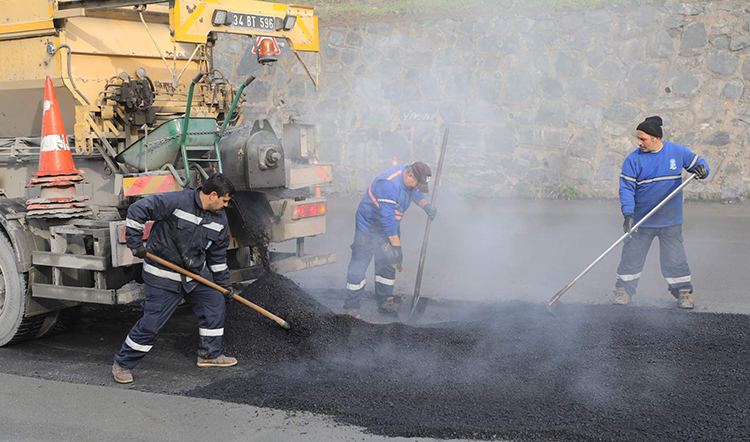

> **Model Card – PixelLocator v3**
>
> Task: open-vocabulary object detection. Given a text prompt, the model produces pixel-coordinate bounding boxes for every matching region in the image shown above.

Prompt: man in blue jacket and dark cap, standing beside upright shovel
[344,161,437,318]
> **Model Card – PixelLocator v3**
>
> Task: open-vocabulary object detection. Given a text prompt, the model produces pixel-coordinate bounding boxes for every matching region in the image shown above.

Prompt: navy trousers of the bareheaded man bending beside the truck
[115,284,226,369]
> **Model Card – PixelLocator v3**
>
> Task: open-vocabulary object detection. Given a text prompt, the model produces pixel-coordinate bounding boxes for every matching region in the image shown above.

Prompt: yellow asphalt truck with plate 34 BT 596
[0,0,336,345]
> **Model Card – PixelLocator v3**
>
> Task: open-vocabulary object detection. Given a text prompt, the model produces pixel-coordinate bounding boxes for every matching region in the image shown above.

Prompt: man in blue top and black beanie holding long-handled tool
[614,116,708,309]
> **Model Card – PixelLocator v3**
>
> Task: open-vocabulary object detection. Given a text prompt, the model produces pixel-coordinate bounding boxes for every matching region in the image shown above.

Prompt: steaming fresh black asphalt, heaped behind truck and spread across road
[185,275,750,441]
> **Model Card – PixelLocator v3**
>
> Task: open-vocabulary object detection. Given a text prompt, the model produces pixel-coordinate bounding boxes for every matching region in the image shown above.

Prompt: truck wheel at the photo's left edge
[0,233,40,347]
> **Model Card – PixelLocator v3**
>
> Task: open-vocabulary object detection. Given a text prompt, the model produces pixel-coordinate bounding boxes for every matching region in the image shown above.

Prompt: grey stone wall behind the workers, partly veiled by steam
[214,0,750,200]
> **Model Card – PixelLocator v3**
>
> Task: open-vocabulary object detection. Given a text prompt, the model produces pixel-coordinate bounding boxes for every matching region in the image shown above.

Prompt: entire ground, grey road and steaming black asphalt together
[0,198,750,440]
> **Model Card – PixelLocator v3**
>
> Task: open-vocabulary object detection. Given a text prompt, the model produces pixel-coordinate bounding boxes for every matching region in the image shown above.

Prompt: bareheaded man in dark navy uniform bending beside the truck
[112,173,237,384]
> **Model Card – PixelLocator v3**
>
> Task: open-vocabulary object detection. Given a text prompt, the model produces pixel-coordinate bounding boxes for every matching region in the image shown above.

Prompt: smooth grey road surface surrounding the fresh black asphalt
[0,196,750,441]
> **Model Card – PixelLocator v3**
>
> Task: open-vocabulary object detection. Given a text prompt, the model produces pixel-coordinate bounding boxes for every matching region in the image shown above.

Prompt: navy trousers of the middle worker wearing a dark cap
[344,228,396,309]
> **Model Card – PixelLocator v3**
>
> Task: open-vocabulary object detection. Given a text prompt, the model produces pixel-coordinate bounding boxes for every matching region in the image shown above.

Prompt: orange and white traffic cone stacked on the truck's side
[26,77,91,218]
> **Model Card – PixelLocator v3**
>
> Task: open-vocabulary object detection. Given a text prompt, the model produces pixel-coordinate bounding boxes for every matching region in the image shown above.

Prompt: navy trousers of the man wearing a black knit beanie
[615,224,693,298]
